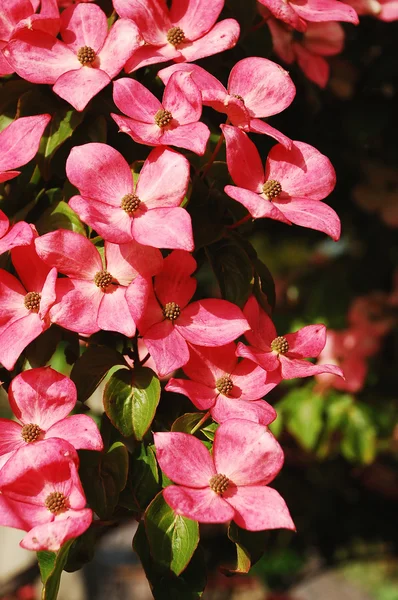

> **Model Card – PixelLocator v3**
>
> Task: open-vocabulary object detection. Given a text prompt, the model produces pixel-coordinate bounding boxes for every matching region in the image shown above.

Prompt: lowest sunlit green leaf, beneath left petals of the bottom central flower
[145,492,199,576]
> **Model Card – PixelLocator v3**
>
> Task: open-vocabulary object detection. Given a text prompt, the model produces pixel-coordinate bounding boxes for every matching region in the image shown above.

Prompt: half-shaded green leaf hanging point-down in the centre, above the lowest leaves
[104,367,160,441]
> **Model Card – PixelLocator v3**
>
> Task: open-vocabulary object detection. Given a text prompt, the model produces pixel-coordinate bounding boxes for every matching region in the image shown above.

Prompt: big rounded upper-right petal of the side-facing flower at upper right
[228,56,296,118]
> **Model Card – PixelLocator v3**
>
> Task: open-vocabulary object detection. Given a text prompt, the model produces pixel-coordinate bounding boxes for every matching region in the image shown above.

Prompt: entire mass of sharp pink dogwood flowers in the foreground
[0,0,354,550]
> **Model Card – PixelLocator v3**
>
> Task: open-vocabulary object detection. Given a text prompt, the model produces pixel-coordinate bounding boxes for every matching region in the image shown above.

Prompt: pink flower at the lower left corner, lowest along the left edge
[0,438,92,552]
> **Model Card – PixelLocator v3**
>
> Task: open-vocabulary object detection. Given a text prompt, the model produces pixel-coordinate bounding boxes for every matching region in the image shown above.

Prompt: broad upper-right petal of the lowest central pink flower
[213,419,283,486]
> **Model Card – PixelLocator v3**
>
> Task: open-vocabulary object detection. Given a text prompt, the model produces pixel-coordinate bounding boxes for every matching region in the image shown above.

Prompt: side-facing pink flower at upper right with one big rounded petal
[158,57,296,148]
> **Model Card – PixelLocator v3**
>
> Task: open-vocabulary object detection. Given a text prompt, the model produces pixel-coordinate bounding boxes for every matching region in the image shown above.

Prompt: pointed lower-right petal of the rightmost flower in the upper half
[275,198,341,242]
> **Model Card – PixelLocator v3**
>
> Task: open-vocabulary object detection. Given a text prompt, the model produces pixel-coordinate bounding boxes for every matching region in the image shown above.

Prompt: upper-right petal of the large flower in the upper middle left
[136,147,190,208]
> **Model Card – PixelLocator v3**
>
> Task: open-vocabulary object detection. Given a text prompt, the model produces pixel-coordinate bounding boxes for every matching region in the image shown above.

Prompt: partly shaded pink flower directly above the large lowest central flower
[166,342,281,425]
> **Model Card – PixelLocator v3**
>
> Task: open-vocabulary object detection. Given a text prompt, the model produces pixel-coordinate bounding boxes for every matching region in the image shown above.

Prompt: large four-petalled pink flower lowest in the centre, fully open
[154,419,295,531]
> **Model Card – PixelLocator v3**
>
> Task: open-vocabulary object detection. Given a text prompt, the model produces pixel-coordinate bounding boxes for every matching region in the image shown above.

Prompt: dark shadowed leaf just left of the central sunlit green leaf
[70,346,127,402]
